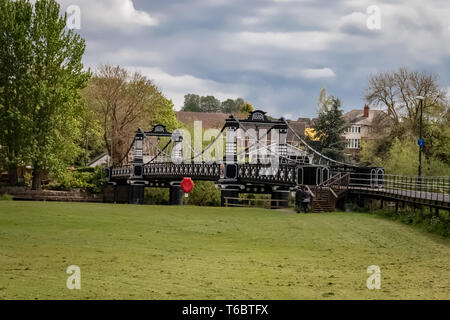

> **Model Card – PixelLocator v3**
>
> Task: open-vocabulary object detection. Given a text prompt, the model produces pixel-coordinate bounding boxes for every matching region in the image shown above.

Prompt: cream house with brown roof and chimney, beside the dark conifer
[344,105,388,159]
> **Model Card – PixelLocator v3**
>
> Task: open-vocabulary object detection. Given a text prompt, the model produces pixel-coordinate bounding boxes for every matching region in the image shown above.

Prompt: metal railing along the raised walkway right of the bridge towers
[350,173,450,202]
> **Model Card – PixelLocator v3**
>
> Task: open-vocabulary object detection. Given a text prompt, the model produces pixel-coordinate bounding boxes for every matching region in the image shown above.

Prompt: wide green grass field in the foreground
[0,201,450,299]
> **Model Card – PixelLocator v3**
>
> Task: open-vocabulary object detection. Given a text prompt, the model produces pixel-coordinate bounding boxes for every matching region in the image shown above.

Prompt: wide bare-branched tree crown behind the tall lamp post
[365,68,447,132]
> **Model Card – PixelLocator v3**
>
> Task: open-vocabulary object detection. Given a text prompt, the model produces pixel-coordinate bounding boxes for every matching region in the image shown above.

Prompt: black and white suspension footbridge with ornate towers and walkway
[106,110,450,212]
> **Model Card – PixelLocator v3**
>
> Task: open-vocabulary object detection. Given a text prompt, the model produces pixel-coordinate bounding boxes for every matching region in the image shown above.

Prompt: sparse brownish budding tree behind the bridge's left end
[85,65,165,165]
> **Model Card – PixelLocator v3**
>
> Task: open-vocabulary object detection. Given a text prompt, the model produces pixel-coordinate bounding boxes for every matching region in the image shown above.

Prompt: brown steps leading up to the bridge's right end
[309,173,350,213]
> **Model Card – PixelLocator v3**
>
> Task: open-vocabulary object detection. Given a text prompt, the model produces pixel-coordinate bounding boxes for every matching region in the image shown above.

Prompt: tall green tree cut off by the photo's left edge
[0,1,33,185]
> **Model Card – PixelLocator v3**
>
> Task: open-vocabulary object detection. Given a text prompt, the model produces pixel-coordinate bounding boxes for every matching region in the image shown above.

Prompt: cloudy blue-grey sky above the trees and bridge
[58,0,450,119]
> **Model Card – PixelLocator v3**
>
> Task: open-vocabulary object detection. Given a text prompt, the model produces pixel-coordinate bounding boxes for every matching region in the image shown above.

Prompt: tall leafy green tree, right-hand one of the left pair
[28,0,90,189]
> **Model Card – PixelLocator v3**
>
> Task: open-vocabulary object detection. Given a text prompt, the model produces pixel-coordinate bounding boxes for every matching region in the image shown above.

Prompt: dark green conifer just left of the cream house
[314,97,347,161]
